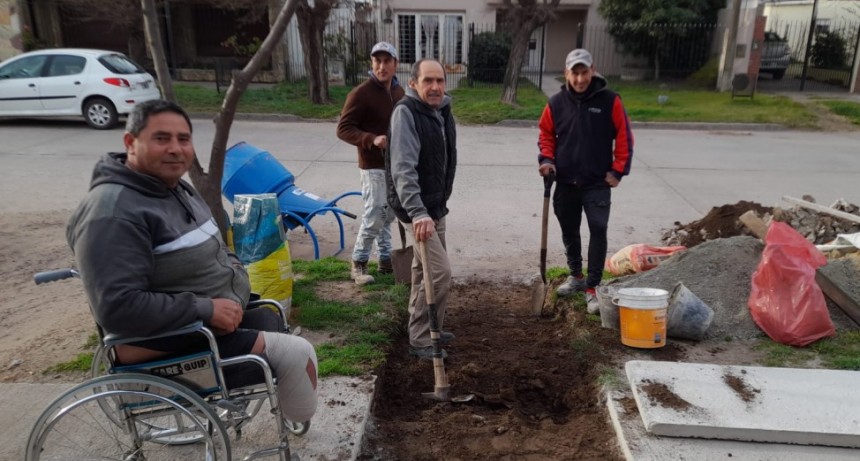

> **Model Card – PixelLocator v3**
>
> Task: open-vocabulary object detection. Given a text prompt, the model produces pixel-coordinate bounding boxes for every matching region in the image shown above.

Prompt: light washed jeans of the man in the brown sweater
[352,170,394,262]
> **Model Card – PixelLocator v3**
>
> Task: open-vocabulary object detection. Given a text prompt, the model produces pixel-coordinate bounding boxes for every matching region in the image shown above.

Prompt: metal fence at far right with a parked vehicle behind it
[759,16,860,91]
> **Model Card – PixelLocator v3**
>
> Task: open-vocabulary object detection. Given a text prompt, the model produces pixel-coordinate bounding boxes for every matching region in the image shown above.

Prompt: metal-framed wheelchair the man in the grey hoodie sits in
[25,269,310,461]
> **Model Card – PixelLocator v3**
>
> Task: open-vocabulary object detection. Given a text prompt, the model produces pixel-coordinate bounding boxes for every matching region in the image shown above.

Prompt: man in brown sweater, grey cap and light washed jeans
[337,42,404,285]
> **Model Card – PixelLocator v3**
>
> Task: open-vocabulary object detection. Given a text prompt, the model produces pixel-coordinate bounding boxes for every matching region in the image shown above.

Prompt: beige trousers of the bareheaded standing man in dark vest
[404,218,451,347]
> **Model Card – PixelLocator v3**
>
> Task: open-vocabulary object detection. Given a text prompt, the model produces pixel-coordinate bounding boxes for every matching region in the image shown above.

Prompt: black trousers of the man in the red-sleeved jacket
[552,183,612,287]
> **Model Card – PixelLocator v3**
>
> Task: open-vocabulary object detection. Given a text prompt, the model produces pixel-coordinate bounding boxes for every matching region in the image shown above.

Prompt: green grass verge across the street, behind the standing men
[174,80,828,128]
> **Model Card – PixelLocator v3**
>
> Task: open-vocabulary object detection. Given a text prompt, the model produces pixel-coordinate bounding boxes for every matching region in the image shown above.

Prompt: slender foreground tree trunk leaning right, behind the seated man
[183,0,299,237]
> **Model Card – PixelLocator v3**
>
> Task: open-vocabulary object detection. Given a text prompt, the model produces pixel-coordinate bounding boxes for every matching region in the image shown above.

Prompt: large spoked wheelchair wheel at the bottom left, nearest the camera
[25,373,231,461]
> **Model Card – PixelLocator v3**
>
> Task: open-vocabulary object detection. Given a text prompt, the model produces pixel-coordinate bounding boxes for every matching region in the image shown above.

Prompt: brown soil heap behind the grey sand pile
[663,200,773,248]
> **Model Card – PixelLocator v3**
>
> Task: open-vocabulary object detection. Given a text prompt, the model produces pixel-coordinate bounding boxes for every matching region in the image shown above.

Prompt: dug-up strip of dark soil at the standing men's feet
[359,281,684,461]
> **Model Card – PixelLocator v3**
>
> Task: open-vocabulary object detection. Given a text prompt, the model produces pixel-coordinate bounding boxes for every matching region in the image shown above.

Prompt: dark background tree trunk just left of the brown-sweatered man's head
[296,0,338,104]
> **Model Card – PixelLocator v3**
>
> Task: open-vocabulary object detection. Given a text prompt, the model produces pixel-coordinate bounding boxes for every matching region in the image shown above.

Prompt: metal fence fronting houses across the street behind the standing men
[285,18,726,89]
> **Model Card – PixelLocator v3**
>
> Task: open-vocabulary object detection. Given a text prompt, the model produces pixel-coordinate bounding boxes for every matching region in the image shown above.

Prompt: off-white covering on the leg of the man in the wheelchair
[263,331,318,422]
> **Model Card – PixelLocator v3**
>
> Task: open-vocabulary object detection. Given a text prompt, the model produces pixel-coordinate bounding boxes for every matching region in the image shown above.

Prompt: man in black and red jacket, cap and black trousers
[538,49,633,298]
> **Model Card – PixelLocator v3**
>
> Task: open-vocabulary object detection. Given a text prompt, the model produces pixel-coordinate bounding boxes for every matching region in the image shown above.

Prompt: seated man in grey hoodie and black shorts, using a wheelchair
[66,100,317,421]
